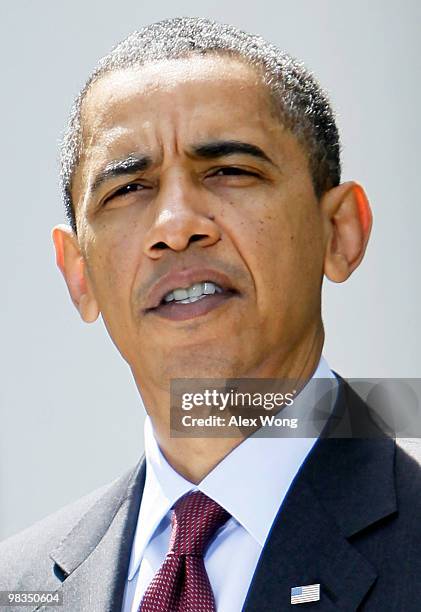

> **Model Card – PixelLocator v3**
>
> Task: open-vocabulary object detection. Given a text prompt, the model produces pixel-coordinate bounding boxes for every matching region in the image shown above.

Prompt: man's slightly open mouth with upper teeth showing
[145,271,239,321]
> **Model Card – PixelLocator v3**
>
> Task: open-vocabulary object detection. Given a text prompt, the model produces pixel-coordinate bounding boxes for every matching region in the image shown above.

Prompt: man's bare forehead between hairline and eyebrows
[82,56,279,155]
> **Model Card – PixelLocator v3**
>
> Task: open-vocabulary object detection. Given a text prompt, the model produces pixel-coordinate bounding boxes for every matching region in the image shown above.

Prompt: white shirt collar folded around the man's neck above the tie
[128,357,335,580]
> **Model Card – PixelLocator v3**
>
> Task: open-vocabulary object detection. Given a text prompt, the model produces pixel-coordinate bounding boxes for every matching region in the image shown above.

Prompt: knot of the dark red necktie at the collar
[170,491,230,556]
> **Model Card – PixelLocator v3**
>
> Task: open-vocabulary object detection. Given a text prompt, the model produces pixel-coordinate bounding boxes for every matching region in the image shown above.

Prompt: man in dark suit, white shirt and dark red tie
[0,18,421,612]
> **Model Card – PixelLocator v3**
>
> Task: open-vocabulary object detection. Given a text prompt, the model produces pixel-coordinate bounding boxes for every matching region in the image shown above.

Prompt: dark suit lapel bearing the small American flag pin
[243,380,396,612]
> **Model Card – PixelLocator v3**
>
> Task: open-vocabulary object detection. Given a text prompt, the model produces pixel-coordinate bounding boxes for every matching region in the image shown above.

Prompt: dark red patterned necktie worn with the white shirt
[138,491,230,612]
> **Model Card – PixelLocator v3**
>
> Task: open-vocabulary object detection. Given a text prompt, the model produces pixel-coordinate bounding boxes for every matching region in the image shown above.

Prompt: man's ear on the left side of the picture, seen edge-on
[52,225,99,323]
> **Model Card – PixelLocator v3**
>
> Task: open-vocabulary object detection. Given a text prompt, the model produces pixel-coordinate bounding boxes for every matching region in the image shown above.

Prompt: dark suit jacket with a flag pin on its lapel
[0,380,421,612]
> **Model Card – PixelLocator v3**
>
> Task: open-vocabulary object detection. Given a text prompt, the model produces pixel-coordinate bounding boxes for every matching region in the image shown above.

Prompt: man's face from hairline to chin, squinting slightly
[73,56,325,385]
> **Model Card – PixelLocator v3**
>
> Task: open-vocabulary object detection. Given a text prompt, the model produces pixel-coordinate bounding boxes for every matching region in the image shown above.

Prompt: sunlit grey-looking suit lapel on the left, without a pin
[32,459,146,612]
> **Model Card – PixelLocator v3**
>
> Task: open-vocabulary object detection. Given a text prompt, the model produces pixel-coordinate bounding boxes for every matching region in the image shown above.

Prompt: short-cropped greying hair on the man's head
[60,17,341,232]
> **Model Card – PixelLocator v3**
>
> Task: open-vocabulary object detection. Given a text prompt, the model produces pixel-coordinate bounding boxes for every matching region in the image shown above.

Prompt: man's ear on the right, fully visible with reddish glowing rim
[321,181,372,283]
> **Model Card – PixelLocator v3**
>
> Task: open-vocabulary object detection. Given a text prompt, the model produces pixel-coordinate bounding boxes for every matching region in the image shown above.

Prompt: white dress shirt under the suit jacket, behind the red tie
[123,357,335,612]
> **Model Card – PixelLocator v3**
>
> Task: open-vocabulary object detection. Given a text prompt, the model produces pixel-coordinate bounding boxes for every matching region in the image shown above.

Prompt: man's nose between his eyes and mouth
[144,173,221,259]
